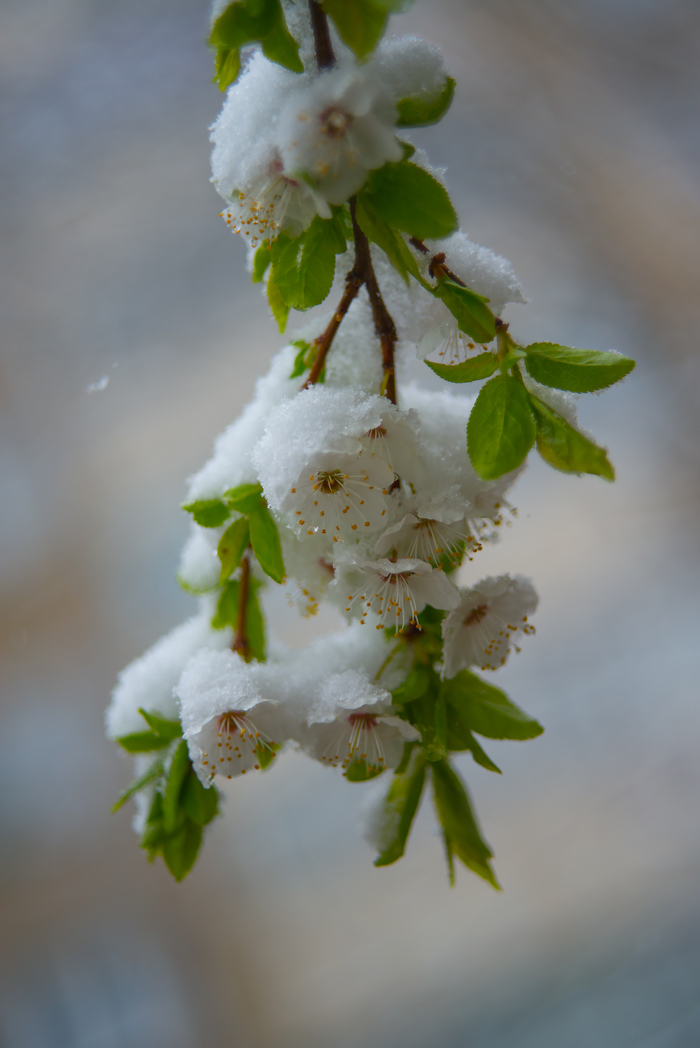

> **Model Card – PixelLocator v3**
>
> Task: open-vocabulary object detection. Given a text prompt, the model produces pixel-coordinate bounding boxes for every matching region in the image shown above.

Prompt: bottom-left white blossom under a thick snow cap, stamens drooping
[175,651,291,786]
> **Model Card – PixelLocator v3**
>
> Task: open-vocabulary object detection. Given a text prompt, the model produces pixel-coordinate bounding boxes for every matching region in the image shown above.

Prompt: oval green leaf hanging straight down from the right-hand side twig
[466,375,537,480]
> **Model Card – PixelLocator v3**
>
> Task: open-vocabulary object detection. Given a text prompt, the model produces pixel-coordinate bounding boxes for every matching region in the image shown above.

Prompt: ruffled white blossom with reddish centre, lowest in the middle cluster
[333,558,459,633]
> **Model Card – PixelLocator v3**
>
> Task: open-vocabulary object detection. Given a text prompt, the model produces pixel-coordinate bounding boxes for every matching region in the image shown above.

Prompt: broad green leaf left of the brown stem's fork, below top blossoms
[270,215,347,310]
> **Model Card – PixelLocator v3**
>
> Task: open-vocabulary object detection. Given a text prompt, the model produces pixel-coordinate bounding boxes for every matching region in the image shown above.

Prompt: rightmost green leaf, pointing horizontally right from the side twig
[525,342,636,393]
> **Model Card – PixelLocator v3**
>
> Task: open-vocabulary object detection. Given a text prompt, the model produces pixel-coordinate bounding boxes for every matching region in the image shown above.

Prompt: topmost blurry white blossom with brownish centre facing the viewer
[280,65,402,204]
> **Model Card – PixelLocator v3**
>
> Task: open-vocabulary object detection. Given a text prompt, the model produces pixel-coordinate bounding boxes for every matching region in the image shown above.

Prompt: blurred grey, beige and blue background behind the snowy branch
[0,0,700,1048]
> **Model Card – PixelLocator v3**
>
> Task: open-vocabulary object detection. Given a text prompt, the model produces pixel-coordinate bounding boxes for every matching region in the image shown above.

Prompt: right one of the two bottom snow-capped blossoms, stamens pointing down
[303,670,420,779]
